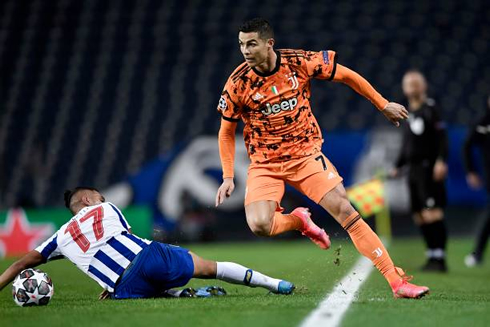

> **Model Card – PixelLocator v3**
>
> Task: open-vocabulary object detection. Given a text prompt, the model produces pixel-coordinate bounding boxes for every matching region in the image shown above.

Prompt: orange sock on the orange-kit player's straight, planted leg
[342,212,400,285]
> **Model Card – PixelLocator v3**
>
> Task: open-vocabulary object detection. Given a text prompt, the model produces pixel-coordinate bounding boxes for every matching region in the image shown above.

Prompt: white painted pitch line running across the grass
[301,257,373,327]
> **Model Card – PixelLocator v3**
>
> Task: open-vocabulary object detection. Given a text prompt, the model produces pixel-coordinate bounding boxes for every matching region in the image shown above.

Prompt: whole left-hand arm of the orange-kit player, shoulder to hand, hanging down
[216,78,241,206]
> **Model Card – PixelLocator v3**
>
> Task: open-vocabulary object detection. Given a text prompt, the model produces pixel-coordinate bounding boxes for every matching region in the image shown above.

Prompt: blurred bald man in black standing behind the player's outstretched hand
[393,70,448,272]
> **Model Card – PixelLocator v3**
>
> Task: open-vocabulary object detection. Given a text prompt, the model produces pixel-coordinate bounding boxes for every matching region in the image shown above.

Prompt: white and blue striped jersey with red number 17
[36,202,151,292]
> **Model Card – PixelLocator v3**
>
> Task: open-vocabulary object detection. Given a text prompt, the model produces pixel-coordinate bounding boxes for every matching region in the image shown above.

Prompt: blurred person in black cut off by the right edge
[464,96,490,267]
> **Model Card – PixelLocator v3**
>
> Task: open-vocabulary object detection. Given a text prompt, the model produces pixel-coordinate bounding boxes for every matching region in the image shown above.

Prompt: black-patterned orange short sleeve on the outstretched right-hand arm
[305,50,337,81]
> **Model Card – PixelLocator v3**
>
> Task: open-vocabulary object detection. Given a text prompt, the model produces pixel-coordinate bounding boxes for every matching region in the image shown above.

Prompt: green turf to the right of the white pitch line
[343,239,490,326]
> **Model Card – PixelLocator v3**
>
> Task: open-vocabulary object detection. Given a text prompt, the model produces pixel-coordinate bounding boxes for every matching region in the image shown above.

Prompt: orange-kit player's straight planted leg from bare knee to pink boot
[320,184,429,299]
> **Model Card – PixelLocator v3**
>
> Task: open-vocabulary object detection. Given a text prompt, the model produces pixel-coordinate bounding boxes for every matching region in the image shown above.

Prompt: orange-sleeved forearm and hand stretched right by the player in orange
[333,64,408,127]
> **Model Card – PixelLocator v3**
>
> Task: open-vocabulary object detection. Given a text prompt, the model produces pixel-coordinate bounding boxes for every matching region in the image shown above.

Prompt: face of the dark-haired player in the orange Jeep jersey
[238,32,274,67]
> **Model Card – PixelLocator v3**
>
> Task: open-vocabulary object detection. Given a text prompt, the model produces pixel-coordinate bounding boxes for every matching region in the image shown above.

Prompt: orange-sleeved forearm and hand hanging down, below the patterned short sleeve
[216,119,237,206]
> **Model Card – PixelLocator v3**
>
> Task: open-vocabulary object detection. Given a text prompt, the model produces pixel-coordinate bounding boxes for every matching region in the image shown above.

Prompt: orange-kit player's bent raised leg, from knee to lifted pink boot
[245,201,330,250]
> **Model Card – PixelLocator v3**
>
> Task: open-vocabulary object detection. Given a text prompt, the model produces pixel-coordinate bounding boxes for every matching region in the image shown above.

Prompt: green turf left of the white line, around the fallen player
[0,242,356,327]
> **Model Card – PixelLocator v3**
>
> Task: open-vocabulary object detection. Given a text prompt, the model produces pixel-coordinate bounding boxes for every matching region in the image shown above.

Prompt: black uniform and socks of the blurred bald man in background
[395,99,448,271]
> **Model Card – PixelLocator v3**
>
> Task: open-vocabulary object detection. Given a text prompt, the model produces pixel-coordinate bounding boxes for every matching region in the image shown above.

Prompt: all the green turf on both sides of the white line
[0,240,490,327]
